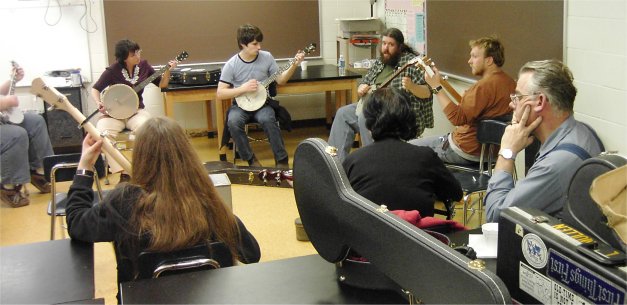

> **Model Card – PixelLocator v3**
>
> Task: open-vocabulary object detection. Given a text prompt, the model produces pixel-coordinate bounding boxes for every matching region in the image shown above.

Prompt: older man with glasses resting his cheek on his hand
[485,60,604,222]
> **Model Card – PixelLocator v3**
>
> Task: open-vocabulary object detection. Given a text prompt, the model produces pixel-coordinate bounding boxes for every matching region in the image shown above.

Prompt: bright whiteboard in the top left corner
[0,0,91,86]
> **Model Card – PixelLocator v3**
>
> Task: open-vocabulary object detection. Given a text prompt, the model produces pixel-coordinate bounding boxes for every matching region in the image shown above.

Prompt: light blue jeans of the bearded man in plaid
[328,103,374,162]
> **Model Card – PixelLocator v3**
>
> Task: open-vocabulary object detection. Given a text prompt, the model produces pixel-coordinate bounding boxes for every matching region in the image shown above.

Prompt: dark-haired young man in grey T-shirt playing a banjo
[217,24,305,167]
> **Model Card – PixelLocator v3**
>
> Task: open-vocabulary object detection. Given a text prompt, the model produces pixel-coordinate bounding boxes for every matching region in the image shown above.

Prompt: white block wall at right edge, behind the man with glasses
[564,0,627,155]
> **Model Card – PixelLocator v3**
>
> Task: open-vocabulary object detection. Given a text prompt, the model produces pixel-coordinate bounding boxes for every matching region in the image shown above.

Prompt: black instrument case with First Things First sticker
[496,208,627,304]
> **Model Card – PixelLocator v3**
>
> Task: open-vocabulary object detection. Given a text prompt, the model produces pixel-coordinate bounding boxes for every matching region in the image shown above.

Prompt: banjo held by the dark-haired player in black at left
[100,51,188,120]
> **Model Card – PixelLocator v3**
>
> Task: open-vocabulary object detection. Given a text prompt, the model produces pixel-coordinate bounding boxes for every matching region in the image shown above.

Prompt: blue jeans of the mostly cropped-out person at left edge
[0,112,54,184]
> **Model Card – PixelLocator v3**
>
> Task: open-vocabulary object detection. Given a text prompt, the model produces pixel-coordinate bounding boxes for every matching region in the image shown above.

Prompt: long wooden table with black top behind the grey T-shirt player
[162,65,361,155]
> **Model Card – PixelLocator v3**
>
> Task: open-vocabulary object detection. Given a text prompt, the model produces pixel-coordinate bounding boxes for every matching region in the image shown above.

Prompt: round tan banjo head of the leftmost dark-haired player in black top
[101,84,139,120]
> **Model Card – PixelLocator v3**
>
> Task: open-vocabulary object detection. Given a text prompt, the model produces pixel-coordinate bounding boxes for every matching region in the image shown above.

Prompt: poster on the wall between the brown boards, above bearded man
[385,0,426,54]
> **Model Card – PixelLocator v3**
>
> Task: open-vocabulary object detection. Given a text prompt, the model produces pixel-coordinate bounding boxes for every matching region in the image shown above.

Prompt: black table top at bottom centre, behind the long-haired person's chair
[120,255,407,304]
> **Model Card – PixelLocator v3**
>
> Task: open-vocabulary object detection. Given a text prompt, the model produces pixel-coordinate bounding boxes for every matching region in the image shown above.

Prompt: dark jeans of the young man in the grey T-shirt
[227,104,287,162]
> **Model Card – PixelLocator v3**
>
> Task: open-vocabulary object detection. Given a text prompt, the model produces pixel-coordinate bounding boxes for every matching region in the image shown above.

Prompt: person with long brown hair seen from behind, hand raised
[66,117,261,300]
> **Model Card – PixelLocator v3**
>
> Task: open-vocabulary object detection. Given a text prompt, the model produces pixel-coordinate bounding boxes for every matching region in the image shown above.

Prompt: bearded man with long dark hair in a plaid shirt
[329,28,433,161]
